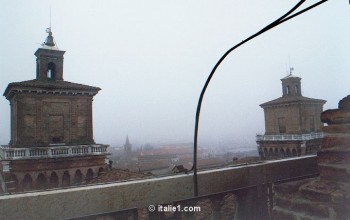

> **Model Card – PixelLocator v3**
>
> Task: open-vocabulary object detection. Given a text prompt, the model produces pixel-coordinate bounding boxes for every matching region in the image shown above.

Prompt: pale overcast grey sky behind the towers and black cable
[0,0,350,150]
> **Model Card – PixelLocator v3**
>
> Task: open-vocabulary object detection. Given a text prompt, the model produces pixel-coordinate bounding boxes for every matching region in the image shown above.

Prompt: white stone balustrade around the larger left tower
[0,144,109,160]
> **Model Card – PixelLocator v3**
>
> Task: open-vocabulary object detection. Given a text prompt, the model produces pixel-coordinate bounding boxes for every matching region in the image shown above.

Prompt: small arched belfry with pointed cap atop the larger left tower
[35,28,65,81]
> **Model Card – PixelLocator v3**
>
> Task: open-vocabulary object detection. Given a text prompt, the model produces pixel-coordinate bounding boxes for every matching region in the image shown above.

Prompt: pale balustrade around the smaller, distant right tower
[256,132,323,141]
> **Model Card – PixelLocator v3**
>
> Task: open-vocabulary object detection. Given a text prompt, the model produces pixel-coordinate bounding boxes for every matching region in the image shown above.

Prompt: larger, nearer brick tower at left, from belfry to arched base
[0,28,108,191]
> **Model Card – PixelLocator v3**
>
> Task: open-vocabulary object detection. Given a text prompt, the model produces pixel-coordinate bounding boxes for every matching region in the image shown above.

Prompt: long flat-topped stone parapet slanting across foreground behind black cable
[0,156,318,220]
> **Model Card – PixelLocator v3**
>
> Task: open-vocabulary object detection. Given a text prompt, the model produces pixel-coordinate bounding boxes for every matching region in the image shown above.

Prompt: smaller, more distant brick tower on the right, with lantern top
[257,74,326,159]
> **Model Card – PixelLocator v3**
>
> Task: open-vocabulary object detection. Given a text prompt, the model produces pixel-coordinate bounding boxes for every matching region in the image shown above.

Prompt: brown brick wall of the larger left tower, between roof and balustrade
[11,94,93,147]
